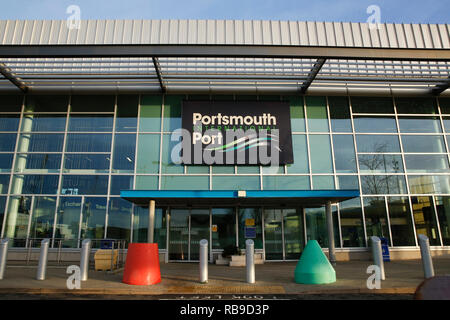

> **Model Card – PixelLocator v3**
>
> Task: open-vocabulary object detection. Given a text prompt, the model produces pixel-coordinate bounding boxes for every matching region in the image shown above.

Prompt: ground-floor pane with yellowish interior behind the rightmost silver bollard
[411,197,441,246]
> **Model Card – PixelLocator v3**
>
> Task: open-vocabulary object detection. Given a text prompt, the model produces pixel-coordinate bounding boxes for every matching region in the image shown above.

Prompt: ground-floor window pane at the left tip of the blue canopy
[106,198,132,241]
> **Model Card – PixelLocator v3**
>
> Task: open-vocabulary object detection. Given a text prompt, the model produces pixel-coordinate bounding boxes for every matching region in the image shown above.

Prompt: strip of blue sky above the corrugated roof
[0,0,450,23]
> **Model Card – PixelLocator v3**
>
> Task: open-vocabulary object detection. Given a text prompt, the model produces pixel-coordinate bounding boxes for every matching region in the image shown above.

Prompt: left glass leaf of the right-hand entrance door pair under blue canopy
[264,209,284,260]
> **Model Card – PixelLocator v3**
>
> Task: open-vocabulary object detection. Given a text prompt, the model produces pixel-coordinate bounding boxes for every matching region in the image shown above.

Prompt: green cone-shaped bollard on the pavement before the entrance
[294,240,336,284]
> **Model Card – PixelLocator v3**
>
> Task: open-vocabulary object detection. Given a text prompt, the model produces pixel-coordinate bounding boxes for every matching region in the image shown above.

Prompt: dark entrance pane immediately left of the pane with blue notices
[211,207,236,249]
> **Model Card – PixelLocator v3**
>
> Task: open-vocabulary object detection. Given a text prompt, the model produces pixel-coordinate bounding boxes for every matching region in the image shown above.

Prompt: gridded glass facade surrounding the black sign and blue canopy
[0,95,450,259]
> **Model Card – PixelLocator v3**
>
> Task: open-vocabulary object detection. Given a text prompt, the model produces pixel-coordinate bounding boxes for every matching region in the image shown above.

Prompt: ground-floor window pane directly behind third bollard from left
[81,197,106,247]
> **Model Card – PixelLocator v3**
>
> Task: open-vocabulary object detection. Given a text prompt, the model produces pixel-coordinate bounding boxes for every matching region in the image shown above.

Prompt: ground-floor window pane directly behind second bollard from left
[29,197,56,239]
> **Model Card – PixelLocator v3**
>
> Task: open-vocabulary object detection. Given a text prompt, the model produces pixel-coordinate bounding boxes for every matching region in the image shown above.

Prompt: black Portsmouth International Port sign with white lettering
[179,101,294,165]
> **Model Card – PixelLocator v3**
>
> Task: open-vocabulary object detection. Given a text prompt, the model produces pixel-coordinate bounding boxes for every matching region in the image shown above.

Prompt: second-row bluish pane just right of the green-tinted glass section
[333,134,356,173]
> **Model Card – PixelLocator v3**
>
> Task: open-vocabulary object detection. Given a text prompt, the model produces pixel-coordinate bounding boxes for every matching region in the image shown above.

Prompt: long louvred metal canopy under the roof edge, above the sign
[0,44,450,95]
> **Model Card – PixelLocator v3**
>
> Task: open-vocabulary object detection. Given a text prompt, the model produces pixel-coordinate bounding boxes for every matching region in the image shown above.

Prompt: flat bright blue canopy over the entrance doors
[120,190,359,207]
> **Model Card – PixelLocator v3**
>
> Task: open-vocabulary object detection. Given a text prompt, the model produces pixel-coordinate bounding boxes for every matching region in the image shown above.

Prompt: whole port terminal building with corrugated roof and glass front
[0,20,450,262]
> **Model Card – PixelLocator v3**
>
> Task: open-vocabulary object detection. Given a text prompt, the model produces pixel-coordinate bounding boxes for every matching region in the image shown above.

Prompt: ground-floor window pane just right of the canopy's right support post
[342,198,366,248]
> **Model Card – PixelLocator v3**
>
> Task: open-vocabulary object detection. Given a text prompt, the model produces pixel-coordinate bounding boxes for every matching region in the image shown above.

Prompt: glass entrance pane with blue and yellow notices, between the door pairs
[238,208,263,249]
